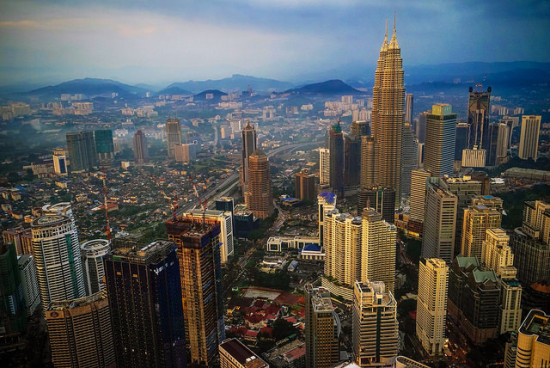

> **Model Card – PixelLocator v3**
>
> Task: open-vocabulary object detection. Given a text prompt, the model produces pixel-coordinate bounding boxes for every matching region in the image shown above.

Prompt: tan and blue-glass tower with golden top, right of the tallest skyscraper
[424,104,456,176]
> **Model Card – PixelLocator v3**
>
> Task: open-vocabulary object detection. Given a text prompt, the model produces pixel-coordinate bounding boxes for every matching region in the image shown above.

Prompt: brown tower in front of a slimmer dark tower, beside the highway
[244,149,273,219]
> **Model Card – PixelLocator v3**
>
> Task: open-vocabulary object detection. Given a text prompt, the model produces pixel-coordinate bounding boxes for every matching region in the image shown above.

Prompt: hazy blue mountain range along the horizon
[11,61,550,100]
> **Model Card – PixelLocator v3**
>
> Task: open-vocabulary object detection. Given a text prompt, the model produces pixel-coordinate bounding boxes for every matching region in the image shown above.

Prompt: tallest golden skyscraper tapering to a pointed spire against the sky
[372,23,405,203]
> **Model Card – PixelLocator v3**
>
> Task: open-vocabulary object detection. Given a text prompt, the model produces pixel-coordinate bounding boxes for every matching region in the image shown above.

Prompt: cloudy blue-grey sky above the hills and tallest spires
[0,0,550,86]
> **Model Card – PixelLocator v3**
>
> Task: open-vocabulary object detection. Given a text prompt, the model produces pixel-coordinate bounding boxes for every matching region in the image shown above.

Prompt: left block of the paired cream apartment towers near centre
[323,209,362,287]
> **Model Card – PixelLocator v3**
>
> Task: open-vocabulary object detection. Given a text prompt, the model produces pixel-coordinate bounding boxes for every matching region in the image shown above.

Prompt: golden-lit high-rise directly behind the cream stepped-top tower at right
[461,195,502,259]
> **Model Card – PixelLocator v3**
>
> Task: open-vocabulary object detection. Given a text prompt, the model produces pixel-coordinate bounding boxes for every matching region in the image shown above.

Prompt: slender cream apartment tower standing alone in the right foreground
[416,258,449,355]
